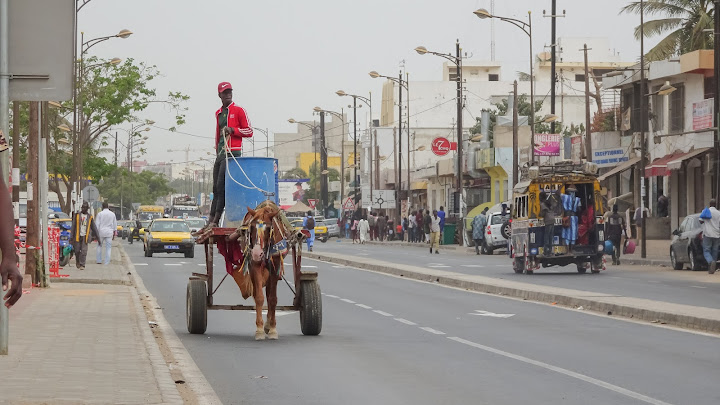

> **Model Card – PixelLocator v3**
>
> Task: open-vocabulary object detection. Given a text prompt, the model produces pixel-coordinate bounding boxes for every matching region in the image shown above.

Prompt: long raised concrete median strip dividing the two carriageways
[303,249,720,333]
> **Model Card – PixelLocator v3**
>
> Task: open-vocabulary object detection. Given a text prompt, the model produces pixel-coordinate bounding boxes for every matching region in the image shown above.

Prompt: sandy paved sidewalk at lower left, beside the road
[0,241,188,404]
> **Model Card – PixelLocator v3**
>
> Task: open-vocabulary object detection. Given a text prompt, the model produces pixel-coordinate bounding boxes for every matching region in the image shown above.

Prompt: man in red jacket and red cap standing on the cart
[204,82,253,230]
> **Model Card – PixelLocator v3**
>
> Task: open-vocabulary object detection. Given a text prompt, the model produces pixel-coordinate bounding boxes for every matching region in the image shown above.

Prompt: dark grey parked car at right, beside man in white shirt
[670,214,708,270]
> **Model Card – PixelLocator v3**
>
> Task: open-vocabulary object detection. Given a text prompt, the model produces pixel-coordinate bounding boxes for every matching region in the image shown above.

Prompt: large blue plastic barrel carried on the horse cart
[223,157,278,228]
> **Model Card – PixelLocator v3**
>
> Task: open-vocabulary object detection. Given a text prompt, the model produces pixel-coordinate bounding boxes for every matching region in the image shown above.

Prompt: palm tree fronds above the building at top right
[620,0,715,61]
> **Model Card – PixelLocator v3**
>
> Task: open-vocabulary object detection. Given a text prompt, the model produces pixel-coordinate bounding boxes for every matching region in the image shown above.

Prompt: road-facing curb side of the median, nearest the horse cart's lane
[303,252,720,333]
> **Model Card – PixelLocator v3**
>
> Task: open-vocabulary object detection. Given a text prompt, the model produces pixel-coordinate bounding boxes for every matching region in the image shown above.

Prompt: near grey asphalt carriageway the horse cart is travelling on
[126,240,720,405]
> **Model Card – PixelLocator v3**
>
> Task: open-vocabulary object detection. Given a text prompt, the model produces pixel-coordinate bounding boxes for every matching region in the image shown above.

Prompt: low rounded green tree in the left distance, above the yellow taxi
[98,167,175,212]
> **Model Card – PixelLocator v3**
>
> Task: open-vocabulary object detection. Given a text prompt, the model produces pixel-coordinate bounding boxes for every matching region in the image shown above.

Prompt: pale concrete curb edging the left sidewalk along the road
[120,247,222,405]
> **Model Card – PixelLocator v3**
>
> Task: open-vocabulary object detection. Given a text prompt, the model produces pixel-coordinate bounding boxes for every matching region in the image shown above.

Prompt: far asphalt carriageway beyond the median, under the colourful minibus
[314,239,720,308]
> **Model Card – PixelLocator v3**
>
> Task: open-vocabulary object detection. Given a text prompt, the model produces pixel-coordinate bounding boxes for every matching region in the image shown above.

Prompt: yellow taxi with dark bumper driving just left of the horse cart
[142,218,195,258]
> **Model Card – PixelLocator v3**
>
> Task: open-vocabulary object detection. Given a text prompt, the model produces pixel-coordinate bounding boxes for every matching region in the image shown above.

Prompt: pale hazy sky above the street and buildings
[78,0,657,166]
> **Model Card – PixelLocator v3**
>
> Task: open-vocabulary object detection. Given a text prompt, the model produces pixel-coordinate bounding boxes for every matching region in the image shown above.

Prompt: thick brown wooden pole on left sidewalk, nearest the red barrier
[25,101,40,284]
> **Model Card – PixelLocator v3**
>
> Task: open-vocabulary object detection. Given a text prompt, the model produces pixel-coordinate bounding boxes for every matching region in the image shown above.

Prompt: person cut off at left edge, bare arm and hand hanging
[0,170,22,308]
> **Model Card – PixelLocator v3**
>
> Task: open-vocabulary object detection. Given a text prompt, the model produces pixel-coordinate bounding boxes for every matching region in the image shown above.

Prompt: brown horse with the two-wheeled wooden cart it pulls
[186,196,322,340]
